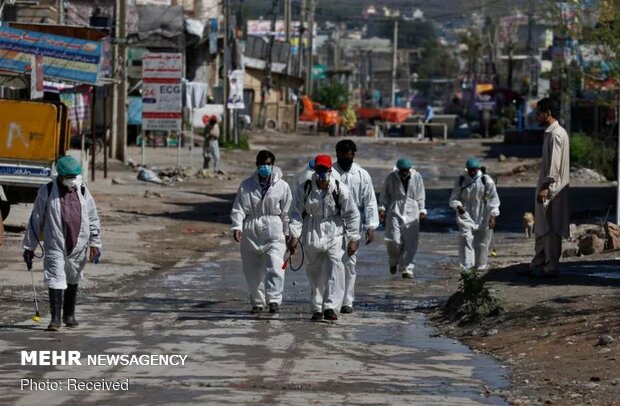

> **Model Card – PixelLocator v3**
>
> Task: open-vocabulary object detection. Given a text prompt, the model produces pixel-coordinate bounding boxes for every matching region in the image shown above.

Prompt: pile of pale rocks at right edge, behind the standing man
[562,222,620,257]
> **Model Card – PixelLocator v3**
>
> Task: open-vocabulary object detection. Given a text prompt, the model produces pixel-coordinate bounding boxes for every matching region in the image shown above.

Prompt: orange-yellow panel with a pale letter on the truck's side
[0,100,62,162]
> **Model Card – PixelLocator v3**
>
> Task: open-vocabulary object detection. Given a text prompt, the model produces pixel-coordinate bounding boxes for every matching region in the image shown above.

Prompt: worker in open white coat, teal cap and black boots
[23,156,101,331]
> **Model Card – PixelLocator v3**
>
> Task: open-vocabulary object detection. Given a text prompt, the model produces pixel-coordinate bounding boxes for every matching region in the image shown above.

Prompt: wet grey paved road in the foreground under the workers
[0,230,507,405]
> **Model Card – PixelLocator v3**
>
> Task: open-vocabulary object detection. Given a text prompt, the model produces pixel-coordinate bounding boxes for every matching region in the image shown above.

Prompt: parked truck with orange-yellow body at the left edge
[0,99,70,219]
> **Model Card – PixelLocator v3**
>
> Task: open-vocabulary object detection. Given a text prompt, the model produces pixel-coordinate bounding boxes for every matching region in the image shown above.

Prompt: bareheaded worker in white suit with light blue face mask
[230,150,292,314]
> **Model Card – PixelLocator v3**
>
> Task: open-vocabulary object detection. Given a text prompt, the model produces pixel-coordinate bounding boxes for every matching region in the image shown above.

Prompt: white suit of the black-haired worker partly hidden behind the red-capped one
[334,162,379,307]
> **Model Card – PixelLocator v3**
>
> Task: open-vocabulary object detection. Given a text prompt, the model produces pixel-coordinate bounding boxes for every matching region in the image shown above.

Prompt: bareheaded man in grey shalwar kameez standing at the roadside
[529,98,570,277]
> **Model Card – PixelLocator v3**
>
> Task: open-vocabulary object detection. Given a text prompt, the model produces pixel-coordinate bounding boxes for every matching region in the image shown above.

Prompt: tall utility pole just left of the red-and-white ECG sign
[112,0,127,162]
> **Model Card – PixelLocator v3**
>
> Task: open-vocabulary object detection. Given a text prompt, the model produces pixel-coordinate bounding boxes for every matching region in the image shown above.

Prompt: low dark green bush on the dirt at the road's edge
[446,269,502,320]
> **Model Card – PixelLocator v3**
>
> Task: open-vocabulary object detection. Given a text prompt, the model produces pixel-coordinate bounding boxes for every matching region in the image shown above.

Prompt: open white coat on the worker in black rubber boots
[23,178,101,290]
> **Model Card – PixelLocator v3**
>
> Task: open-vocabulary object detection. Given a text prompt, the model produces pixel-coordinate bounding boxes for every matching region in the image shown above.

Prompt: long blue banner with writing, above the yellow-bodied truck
[0,26,102,85]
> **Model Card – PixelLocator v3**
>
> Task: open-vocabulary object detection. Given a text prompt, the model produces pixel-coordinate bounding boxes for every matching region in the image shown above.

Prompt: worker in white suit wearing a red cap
[289,155,360,321]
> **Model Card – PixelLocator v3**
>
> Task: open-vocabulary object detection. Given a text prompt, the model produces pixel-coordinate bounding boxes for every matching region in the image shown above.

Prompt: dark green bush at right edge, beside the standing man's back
[570,133,617,180]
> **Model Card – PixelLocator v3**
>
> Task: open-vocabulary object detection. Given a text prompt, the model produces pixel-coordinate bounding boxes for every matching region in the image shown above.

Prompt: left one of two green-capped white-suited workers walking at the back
[379,158,426,278]
